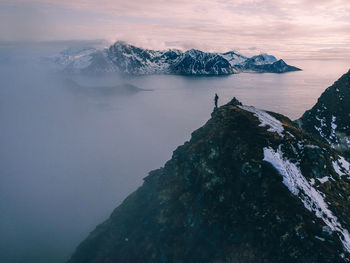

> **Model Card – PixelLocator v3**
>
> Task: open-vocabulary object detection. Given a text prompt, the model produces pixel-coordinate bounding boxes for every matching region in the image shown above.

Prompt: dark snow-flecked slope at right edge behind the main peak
[297,70,350,158]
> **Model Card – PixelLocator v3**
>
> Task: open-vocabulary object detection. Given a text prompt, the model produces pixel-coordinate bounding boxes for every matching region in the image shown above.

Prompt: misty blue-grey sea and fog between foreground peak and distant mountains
[0,44,350,263]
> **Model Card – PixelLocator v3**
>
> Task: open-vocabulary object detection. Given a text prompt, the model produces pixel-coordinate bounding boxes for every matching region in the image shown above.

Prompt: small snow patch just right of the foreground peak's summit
[238,106,284,138]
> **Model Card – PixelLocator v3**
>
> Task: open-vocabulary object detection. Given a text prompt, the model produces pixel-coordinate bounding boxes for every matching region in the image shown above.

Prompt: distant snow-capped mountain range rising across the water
[54,41,299,75]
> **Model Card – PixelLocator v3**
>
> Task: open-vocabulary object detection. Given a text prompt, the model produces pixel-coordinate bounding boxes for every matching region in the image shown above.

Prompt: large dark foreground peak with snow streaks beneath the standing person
[69,99,350,263]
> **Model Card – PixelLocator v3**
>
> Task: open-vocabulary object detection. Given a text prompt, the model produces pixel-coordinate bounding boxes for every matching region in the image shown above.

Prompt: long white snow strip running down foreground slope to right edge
[264,147,350,252]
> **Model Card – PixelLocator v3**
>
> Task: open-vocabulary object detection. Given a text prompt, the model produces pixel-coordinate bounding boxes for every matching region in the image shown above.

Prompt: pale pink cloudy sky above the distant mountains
[0,0,350,58]
